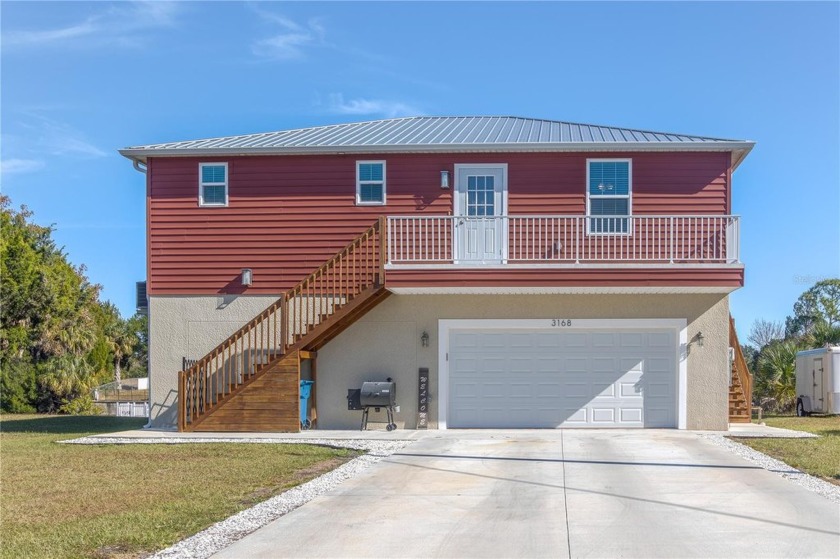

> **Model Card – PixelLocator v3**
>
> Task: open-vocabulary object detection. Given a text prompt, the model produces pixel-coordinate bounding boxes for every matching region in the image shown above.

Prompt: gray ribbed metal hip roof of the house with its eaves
[120,116,753,168]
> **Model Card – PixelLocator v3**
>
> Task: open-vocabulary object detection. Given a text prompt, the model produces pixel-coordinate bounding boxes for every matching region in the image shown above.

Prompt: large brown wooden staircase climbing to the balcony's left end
[178,217,389,432]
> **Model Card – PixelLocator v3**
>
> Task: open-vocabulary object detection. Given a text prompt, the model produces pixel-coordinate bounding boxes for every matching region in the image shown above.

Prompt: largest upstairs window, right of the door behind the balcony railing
[586,159,633,234]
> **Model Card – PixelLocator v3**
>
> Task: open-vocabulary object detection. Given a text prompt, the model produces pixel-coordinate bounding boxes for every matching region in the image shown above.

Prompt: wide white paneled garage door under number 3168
[448,329,677,428]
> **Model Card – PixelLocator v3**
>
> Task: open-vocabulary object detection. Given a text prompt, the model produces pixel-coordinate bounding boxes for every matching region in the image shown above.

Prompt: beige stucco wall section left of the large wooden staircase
[149,295,277,429]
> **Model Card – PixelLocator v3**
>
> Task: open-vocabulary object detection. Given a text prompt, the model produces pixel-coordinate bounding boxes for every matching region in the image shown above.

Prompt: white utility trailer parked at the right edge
[796,347,840,417]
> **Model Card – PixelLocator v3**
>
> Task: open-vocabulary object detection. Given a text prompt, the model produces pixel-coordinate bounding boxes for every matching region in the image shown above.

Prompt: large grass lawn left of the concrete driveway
[0,415,356,559]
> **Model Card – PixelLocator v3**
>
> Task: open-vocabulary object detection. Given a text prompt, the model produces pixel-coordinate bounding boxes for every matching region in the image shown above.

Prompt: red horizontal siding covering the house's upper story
[148,153,729,295]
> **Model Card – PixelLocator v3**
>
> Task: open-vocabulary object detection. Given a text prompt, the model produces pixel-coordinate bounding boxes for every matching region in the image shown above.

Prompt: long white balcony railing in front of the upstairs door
[387,215,739,266]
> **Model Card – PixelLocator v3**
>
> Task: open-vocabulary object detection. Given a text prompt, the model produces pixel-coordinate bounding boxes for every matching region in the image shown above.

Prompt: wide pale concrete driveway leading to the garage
[215,430,840,558]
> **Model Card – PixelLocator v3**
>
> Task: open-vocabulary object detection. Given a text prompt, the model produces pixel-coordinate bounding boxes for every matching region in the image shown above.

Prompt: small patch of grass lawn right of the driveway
[735,415,840,485]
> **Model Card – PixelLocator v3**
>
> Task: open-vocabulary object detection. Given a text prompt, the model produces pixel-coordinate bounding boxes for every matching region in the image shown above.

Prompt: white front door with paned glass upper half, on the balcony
[453,164,507,264]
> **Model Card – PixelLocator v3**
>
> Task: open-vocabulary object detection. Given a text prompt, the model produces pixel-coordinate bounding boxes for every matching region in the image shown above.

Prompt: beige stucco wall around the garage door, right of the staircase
[316,294,729,430]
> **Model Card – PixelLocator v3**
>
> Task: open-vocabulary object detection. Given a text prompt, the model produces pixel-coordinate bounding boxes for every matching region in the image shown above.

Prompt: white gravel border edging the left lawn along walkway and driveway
[61,437,415,559]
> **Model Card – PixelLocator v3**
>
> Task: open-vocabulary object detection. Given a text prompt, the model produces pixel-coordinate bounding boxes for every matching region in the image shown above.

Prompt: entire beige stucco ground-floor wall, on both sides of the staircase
[149,294,729,430]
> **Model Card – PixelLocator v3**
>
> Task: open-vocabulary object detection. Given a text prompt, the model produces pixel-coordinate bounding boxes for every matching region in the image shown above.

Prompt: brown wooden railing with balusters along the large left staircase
[178,217,387,431]
